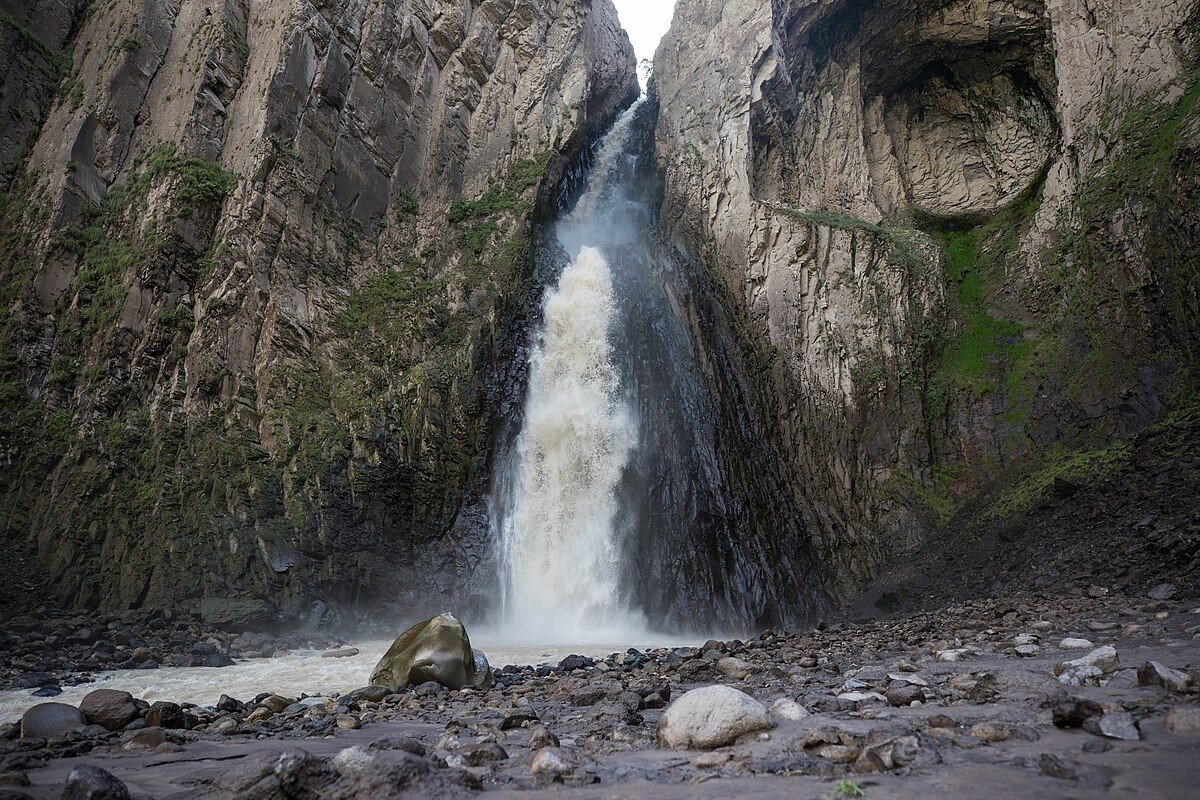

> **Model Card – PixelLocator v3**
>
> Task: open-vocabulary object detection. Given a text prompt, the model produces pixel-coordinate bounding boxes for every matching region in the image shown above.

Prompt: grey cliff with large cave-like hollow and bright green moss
[653,0,1200,601]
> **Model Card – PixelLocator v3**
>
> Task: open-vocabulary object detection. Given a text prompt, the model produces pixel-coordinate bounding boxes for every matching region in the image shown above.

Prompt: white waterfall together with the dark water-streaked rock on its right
[492,98,817,643]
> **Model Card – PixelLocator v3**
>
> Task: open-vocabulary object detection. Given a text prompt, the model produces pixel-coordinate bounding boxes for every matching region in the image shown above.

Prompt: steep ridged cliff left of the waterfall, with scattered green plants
[0,0,637,621]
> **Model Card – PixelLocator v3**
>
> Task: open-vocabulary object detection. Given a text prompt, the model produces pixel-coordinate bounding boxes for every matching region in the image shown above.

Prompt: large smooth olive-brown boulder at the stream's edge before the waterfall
[371,613,492,690]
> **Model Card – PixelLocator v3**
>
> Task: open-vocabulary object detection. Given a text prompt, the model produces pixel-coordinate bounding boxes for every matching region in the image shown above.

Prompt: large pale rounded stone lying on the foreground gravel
[658,686,775,750]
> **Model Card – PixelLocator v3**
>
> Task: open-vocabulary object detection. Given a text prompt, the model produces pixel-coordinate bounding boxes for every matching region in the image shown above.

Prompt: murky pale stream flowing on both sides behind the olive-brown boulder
[0,633,695,722]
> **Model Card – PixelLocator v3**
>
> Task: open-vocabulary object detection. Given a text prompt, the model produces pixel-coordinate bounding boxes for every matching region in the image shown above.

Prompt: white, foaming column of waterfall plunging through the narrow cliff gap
[499,101,644,642]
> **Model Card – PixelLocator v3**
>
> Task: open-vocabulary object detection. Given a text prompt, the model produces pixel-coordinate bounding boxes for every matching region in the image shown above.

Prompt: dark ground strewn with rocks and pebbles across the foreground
[0,584,1200,799]
